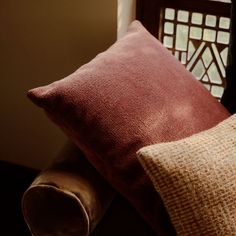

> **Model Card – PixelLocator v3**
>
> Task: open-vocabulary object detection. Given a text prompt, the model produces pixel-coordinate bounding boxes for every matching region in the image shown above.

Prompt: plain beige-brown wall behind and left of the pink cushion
[0,0,117,168]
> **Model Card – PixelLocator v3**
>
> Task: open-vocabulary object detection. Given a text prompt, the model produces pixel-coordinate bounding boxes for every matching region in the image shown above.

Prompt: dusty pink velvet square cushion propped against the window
[28,21,228,235]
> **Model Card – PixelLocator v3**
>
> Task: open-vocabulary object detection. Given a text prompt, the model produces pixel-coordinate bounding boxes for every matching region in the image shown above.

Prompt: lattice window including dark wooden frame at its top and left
[137,0,231,100]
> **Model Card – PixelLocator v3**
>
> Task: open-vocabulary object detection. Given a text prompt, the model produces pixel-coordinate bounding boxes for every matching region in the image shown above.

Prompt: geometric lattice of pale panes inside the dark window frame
[159,8,230,99]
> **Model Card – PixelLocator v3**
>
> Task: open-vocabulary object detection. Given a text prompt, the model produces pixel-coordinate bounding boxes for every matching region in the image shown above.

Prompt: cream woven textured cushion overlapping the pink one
[137,115,236,236]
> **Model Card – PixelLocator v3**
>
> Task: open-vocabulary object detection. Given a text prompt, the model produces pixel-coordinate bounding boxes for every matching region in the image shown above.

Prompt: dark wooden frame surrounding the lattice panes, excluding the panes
[136,0,236,108]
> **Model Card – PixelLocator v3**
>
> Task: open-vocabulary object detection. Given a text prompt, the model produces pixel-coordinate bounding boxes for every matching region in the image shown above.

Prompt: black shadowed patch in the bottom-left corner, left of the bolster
[0,161,38,236]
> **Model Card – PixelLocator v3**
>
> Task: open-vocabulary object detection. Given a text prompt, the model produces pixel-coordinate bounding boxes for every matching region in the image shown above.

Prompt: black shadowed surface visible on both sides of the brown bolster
[0,161,155,236]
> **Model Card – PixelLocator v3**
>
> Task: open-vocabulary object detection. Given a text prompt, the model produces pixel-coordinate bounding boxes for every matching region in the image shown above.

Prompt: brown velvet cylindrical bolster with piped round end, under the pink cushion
[22,142,115,236]
